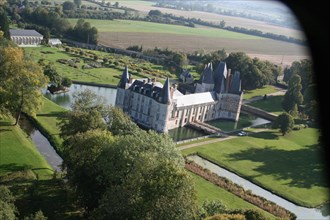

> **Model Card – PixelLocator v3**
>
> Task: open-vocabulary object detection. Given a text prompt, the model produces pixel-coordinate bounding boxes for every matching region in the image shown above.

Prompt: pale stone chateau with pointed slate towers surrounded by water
[116,62,243,132]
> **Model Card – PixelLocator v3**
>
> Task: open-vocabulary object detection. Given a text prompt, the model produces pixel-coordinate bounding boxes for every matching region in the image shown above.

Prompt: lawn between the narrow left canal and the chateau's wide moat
[36,97,67,151]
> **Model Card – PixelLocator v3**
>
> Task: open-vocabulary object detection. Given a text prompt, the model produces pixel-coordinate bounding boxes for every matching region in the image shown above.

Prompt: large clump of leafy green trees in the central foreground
[61,90,197,219]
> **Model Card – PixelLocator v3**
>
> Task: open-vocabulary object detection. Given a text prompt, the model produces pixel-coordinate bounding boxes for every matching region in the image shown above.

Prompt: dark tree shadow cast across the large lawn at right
[229,145,329,188]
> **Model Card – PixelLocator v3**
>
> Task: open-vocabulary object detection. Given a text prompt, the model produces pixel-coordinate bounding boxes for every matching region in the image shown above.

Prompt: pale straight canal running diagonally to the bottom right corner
[187,155,329,219]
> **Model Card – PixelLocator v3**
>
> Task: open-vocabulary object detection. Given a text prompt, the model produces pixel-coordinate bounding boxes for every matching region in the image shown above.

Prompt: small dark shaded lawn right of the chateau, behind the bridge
[249,96,284,115]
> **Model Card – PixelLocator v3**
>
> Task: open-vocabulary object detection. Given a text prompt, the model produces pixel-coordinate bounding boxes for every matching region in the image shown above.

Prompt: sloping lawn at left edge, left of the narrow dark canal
[0,118,53,179]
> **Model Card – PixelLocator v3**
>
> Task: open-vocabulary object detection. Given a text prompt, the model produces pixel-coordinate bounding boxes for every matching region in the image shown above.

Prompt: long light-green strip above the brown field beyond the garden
[69,19,263,40]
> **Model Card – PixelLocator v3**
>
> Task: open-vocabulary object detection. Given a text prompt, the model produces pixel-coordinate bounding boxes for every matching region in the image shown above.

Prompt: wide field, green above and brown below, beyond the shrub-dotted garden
[70,19,308,65]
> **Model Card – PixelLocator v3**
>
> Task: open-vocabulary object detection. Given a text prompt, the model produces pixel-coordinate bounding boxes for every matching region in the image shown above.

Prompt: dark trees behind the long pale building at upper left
[0,0,98,44]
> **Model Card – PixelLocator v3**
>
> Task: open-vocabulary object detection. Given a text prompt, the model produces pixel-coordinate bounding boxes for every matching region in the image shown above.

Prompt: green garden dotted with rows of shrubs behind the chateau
[24,47,176,85]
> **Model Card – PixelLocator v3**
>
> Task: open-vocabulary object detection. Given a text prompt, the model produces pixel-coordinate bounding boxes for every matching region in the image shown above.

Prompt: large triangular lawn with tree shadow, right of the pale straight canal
[183,128,329,207]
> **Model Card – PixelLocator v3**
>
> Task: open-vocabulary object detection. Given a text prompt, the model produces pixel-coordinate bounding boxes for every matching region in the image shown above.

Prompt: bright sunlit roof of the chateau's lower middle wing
[176,92,216,108]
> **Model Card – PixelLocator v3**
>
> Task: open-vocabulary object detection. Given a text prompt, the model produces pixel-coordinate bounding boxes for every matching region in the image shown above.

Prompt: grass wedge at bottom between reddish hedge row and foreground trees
[190,173,276,219]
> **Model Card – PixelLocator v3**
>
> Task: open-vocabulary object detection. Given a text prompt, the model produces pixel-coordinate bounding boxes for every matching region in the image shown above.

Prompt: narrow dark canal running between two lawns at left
[19,116,63,171]
